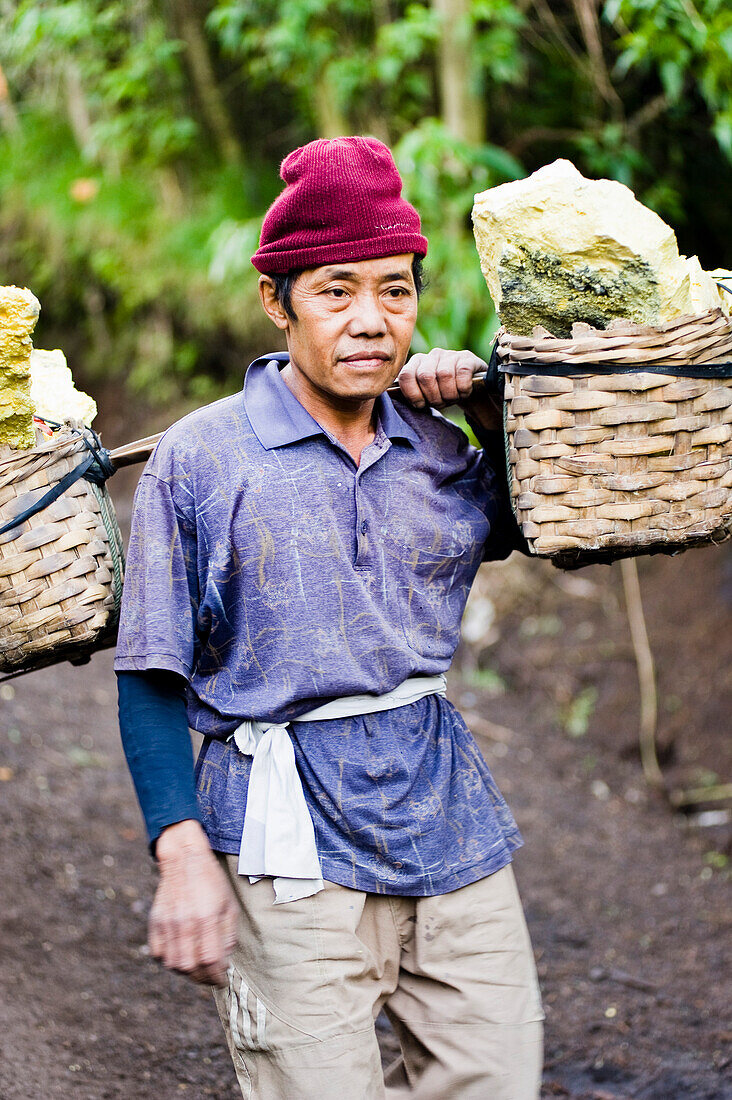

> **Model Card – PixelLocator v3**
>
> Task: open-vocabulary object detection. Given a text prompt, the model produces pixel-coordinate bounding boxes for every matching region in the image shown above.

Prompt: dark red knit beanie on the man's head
[252,138,427,275]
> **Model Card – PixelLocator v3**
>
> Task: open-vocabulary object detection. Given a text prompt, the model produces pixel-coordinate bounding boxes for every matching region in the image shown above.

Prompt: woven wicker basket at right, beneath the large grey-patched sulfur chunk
[498,310,732,568]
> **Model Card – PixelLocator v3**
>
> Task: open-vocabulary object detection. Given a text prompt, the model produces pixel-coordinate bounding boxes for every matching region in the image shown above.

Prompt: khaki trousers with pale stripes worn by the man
[215,856,543,1100]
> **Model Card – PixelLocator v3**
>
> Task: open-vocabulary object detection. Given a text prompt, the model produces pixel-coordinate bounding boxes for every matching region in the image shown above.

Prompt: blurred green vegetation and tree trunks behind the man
[0,0,732,403]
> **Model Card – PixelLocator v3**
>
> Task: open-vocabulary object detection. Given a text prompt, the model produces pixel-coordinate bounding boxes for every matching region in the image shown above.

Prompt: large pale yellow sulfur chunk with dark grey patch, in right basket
[473,161,729,339]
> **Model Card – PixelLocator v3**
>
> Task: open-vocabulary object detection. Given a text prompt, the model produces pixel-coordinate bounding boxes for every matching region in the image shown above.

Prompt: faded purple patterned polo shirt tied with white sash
[116,355,521,895]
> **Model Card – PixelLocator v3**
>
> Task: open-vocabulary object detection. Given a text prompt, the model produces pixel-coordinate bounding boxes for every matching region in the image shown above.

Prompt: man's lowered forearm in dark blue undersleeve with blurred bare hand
[118,670,237,986]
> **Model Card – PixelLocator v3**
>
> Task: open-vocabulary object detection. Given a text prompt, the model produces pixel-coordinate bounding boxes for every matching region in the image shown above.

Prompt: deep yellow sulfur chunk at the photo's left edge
[0,286,41,449]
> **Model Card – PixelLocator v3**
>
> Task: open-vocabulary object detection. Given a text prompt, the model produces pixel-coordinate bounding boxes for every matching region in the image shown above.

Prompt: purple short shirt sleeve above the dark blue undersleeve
[114,471,198,680]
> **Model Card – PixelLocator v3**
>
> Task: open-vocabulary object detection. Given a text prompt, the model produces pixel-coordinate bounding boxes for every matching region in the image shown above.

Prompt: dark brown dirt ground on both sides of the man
[0,407,732,1100]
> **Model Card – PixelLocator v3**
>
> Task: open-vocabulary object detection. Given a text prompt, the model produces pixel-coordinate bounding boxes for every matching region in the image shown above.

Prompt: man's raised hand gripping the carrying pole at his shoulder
[396,348,502,429]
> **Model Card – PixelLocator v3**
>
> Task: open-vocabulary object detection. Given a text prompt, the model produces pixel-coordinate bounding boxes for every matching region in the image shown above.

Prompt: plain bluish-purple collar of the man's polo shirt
[244,352,419,451]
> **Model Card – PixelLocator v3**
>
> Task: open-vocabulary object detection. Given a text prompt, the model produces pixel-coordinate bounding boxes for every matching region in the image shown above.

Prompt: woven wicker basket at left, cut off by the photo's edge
[0,424,123,673]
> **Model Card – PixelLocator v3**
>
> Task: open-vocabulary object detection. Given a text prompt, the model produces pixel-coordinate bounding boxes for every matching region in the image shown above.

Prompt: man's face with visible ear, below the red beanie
[259,253,417,404]
